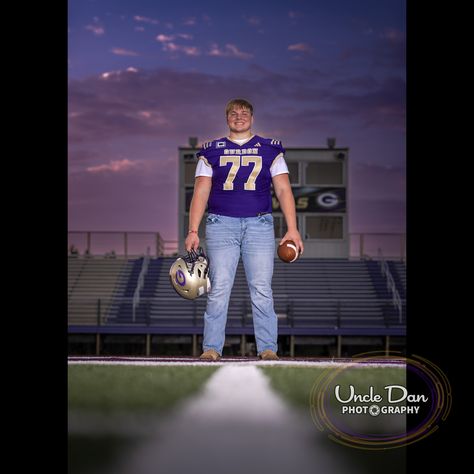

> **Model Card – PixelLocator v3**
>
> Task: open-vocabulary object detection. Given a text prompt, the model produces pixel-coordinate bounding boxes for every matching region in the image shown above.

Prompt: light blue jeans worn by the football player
[203,213,278,355]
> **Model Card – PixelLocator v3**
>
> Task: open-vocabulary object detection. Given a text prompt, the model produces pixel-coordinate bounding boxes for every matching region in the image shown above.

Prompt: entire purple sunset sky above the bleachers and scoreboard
[68,0,406,240]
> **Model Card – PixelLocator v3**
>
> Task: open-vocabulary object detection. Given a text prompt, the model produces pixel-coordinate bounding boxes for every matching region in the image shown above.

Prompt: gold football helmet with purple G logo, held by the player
[170,247,211,300]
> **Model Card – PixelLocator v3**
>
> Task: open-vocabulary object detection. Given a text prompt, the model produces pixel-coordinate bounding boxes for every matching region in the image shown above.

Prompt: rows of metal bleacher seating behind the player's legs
[68,257,406,335]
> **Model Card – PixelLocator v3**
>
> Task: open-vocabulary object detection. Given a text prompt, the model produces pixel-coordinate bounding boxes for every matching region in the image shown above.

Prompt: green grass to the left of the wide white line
[68,365,218,474]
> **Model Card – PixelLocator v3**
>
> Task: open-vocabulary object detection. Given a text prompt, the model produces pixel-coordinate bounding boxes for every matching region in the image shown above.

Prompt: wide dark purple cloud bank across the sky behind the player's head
[68,65,405,179]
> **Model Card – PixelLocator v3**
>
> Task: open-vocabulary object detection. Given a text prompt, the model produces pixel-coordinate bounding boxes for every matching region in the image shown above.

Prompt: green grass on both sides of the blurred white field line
[68,364,405,474]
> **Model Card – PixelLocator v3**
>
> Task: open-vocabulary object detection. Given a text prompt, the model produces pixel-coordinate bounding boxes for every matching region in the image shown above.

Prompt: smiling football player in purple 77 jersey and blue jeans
[185,99,304,360]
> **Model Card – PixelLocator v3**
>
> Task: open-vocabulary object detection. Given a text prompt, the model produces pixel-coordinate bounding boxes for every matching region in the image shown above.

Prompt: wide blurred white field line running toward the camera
[110,364,359,474]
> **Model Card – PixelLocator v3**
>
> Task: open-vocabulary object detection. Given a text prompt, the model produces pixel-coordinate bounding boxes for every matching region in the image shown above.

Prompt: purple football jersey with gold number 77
[196,135,285,217]
